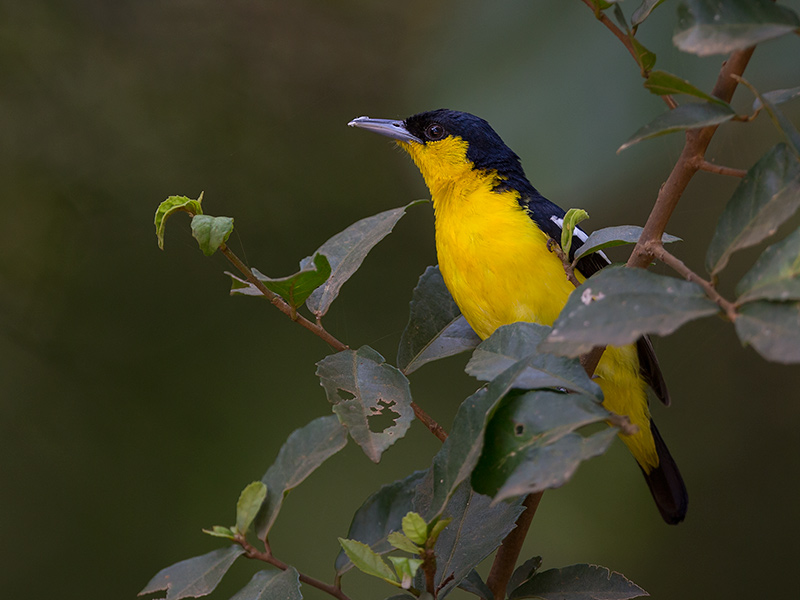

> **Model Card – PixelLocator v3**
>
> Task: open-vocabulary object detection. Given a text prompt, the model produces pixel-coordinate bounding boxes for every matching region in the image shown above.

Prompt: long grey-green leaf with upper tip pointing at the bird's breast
[300,200,427,317]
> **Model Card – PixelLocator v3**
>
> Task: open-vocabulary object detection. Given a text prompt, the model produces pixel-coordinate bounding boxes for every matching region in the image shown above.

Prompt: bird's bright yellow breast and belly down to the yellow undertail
[434,188,658,472]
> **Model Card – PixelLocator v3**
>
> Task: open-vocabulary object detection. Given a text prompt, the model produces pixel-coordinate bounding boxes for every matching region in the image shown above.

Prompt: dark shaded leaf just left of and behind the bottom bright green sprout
[335,471,427,576]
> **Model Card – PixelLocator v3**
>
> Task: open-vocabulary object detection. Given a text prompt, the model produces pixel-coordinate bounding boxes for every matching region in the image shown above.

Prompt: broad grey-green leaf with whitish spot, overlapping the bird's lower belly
[539,266,719,356]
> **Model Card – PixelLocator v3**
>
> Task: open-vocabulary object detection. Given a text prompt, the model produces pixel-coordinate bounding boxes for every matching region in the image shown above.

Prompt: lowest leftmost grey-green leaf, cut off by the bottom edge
[139,544,244,600]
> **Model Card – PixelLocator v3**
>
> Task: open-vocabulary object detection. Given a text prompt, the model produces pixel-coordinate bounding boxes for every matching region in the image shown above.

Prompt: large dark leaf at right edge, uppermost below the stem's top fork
[706,144,800,275]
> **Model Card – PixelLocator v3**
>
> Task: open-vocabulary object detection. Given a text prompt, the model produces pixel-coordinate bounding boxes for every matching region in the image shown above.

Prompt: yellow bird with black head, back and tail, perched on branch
[348,108,688,524]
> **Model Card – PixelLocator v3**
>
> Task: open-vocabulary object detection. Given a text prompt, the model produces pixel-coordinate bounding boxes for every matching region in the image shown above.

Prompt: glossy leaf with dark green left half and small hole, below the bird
[472,390,617,503]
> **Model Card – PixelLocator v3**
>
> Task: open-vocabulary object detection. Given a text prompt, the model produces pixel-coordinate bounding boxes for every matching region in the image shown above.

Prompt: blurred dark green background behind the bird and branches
[0,0,800,600]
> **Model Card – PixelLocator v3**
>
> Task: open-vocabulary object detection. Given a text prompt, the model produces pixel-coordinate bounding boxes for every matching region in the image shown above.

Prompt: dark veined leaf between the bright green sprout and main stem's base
[434,482,523,598]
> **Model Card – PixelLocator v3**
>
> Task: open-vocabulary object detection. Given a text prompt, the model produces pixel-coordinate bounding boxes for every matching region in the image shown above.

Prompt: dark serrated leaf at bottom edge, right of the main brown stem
[509,565,649,600]
